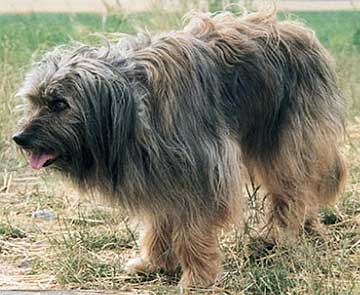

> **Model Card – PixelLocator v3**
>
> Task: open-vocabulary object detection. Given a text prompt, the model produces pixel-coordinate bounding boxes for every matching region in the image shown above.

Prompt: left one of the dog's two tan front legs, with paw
[126,217,177,273]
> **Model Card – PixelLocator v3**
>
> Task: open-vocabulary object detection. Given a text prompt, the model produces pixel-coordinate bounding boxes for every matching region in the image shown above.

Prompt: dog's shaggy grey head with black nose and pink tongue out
[13,46,139,188]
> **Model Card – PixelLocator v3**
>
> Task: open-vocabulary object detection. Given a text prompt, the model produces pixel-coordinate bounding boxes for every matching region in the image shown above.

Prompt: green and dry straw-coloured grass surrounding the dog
[0,5,360,295]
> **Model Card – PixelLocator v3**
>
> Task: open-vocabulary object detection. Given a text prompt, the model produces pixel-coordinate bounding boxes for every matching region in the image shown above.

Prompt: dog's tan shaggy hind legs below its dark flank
[248,140,346,242]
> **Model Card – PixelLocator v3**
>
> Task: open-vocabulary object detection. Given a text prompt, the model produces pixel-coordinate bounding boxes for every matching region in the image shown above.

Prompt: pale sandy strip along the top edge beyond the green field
[0,0,360,13]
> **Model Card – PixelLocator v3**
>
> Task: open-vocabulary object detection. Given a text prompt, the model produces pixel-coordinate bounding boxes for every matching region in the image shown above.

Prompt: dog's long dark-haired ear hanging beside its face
[67,58,136,189]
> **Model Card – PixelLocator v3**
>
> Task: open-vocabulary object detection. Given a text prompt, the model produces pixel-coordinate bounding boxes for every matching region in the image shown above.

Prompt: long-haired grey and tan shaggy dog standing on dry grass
[13,13,346,287]
